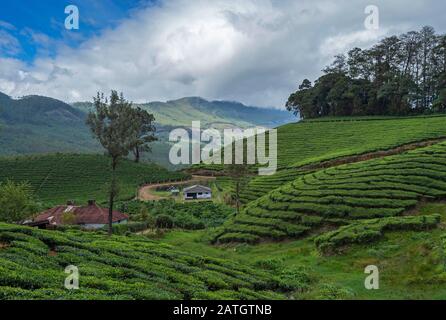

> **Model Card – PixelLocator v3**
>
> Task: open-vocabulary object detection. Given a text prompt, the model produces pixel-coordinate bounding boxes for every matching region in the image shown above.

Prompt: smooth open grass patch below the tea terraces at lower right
[163,203,446,299]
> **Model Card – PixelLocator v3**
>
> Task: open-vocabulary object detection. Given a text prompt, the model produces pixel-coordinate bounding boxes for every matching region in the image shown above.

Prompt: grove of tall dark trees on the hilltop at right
[286,27,446,119]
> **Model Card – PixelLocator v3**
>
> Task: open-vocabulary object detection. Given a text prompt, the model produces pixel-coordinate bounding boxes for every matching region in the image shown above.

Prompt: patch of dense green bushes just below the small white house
[120,200,234,230]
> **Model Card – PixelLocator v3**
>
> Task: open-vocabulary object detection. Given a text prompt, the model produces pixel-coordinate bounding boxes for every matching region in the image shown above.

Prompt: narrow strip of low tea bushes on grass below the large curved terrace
[315,215,440,253]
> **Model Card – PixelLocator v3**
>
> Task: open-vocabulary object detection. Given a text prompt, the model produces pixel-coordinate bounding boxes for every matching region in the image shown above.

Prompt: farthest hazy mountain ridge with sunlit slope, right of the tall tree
[73,97,296,128]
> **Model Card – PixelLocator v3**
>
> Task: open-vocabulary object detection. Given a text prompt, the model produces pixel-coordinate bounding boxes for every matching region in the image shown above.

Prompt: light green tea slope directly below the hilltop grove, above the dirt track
[237,116,446,202]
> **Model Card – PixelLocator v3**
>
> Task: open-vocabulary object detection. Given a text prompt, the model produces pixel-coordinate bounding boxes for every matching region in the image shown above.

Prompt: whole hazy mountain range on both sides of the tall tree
[0,93,295,163]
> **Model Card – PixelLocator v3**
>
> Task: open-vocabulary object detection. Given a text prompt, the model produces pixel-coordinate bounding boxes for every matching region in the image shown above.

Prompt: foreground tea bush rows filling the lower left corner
[0,224,307,299]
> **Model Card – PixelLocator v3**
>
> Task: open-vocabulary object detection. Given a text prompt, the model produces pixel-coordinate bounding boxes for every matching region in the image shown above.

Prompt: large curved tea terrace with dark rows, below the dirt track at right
[215,142,446,243]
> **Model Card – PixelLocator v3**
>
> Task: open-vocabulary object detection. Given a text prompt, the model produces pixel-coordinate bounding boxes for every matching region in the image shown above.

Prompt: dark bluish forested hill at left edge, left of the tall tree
[0,93,98,155]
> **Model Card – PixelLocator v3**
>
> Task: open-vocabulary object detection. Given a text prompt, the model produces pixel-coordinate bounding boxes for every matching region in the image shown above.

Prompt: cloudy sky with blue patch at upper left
[0,0,446,108]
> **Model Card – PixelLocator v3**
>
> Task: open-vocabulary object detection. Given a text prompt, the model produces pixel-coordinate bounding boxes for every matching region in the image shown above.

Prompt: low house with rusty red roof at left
[24,200,129,229]
